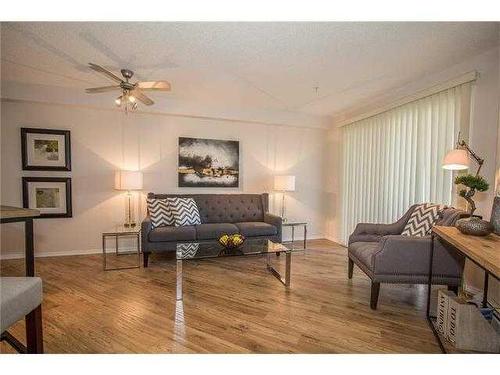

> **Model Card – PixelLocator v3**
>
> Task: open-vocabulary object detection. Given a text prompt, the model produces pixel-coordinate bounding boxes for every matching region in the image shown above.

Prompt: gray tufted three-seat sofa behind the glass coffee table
[141,193,282,267]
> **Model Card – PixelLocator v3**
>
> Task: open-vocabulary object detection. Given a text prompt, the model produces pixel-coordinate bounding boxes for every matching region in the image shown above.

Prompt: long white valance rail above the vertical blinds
[334,70,479,128]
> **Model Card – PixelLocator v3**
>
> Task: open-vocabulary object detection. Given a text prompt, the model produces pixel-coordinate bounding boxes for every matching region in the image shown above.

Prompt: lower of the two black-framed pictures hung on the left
[23,177,73,218]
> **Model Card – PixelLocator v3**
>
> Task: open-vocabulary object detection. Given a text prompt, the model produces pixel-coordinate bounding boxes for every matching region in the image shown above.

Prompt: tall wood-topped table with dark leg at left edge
[0,206,40,276]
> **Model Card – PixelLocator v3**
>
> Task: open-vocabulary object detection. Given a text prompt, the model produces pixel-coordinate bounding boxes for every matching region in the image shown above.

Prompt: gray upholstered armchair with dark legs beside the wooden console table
[348,205,467,309]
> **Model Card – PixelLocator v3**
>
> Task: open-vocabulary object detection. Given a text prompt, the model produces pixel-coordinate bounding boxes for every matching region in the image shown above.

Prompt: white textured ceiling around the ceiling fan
[1,22,499,120]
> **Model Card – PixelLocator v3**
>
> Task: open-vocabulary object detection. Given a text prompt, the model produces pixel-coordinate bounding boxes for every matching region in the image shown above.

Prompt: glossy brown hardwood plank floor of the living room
[0,240,439,353]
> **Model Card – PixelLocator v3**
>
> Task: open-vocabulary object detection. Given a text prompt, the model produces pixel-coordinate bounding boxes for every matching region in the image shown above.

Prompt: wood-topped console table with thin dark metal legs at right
[426,226,500,353]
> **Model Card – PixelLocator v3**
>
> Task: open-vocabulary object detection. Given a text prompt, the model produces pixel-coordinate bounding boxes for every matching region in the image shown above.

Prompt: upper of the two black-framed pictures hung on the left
[21,128,71,171]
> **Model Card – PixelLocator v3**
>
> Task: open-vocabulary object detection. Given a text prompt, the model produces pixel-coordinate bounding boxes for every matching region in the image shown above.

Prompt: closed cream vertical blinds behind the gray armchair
[342,83,471,244]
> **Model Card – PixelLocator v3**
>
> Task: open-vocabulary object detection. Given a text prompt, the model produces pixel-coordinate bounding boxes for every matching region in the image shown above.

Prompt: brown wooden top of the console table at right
[432,225,500,278]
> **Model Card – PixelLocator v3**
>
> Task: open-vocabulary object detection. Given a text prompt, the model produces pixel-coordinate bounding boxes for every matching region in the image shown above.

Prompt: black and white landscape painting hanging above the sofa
[177,137,240,188]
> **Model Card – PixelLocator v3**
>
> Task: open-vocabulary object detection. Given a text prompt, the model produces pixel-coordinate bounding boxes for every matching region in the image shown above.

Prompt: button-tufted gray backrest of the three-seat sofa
[148,193,269,224]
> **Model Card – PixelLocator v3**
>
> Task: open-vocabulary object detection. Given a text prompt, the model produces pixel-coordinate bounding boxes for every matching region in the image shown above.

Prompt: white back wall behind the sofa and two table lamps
[1,100,327,257]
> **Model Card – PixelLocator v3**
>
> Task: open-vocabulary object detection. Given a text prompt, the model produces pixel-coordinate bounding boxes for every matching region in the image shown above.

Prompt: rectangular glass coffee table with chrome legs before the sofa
[176,239,293,301]
